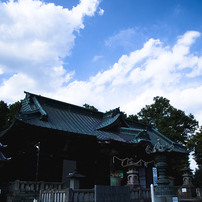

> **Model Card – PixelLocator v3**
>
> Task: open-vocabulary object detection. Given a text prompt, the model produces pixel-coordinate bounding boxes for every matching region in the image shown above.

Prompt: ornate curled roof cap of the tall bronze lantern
[145,139,174,154]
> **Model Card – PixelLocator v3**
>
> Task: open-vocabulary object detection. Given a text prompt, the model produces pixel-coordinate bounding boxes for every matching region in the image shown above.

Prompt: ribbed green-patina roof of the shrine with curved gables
[0,92,187,153]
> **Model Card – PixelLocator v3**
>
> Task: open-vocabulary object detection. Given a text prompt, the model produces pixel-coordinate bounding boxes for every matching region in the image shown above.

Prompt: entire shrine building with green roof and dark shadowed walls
[0,92,188,191]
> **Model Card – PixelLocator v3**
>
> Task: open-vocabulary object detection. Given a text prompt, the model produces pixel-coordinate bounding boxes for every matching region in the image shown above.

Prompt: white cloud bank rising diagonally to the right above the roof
[45,31,202,125]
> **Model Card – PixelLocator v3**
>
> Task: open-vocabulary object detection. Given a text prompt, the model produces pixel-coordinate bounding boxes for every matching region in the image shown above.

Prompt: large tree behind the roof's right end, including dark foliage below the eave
[133,96,198,185]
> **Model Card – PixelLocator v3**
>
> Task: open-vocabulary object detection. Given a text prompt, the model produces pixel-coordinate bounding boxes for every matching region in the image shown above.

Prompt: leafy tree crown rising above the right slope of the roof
[133,96,198,145]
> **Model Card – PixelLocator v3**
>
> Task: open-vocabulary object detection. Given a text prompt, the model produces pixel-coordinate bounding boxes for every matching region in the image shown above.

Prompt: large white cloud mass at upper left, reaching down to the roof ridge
[0,0,99,102]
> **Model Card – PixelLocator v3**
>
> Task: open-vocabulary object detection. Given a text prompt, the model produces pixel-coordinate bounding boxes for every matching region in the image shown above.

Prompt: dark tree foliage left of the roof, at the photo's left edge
[0,101,20,131]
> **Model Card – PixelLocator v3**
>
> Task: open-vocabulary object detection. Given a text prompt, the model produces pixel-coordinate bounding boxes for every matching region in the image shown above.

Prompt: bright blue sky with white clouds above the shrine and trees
[0,0,202,170]
